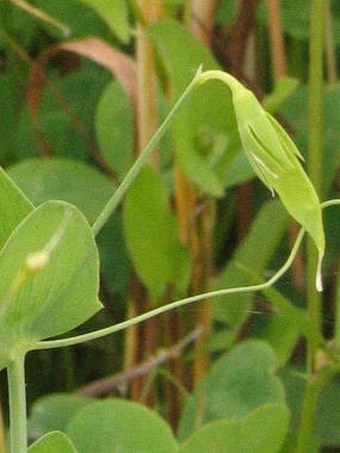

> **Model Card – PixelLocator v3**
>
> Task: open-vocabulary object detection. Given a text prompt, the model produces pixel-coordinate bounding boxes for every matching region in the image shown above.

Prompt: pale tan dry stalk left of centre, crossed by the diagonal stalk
[124,0,162,405]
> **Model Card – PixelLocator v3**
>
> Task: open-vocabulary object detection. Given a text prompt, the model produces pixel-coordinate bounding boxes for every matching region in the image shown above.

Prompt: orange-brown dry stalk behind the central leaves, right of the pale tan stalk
[181,0,218,387]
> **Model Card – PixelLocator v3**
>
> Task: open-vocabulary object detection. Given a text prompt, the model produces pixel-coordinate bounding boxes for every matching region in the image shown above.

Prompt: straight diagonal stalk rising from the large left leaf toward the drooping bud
[92,68,202,236]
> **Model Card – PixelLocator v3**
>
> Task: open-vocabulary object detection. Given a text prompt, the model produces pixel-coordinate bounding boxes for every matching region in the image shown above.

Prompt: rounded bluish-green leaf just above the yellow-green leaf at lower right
[179,340,284,440]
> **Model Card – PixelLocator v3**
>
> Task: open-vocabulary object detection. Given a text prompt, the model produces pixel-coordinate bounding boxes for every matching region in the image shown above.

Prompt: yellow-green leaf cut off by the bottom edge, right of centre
[179,404,289,453]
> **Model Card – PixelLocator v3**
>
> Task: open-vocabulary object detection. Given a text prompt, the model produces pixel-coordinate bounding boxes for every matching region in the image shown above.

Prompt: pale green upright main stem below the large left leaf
[7,355,27,453]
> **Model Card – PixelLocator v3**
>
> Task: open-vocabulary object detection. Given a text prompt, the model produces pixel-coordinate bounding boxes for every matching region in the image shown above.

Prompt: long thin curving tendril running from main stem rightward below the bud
[32,229,305,350]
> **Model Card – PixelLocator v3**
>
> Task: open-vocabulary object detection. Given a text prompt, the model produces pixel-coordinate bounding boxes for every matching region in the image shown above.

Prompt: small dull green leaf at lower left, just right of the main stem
[28,393,93,437]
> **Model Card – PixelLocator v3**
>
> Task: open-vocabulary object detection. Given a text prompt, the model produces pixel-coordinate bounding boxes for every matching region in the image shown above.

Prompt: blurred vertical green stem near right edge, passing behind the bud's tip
[297,0,325,453]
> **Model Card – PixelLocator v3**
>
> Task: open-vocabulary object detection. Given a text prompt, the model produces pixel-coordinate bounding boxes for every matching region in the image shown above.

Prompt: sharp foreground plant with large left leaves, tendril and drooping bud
[0,70,332,453]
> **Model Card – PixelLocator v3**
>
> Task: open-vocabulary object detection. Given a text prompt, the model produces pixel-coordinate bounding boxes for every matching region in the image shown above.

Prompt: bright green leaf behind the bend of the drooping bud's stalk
[148,19,240,196]
